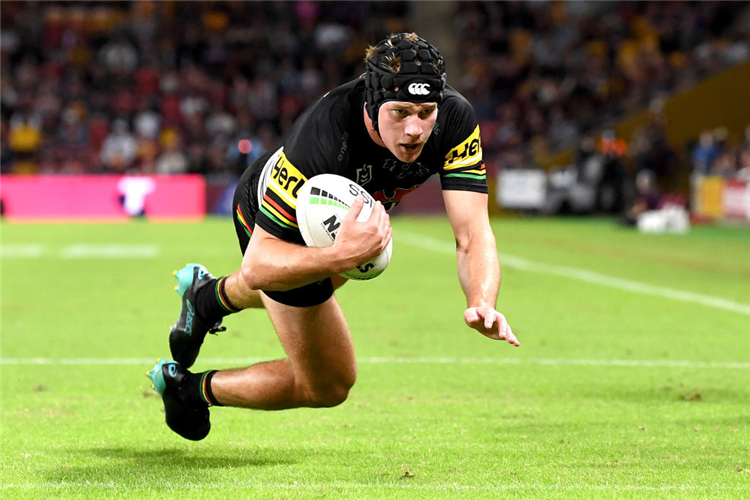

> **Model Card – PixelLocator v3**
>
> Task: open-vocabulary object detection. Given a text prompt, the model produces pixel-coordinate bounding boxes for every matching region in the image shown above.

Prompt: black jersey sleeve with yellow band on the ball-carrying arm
[255,93,345,245]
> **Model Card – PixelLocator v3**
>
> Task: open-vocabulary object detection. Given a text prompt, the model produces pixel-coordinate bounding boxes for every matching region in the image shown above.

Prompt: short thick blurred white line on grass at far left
[0,243,160,259]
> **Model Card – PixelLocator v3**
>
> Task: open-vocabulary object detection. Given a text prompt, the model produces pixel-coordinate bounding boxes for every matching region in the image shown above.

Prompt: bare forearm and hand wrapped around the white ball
[242,196,391,291]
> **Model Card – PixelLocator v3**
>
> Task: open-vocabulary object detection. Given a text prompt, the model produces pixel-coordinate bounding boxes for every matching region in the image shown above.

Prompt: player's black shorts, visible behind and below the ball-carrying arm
[232,151,333,307]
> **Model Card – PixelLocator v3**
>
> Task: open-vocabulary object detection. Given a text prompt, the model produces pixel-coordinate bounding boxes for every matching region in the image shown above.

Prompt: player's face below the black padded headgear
[378,101,437,163]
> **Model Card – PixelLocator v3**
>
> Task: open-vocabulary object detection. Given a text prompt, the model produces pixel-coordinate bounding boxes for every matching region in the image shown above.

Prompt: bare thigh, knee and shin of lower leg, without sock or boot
[210,294,357,410]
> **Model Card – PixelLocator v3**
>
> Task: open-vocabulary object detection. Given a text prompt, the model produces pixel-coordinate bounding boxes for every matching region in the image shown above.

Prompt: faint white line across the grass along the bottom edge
[0,479,747,493]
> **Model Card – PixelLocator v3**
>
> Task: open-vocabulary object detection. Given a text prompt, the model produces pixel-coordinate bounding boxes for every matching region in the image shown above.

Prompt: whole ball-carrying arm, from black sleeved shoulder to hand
[242,85,390,291]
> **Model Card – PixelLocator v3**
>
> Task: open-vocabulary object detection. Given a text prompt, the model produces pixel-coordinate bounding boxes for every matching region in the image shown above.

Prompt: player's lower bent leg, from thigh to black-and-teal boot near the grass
[147,289,357,441]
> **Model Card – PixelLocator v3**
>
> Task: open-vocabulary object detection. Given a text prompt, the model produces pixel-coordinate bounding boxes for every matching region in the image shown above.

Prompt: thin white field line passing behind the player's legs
[0,357,750,370]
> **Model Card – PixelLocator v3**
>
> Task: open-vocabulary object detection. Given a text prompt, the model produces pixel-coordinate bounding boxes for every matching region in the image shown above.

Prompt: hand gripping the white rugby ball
[333,195,393,269]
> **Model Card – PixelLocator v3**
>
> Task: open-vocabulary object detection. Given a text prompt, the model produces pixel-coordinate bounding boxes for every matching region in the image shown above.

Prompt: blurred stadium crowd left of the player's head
[0,0,409,180]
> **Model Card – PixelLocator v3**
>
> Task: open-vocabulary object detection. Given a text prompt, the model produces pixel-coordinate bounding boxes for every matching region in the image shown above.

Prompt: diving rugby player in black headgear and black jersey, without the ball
[148,33,519,440]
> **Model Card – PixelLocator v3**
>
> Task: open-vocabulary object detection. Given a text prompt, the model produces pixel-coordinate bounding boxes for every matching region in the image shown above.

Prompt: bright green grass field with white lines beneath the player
[0,218,750,500]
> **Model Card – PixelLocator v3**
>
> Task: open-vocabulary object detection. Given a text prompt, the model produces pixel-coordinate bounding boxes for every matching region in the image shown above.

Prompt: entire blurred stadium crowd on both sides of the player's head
[0,0,750,201]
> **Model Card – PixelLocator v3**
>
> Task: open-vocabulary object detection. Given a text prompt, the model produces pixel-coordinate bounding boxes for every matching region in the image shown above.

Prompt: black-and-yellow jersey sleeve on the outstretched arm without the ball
[440,96,488,193]
